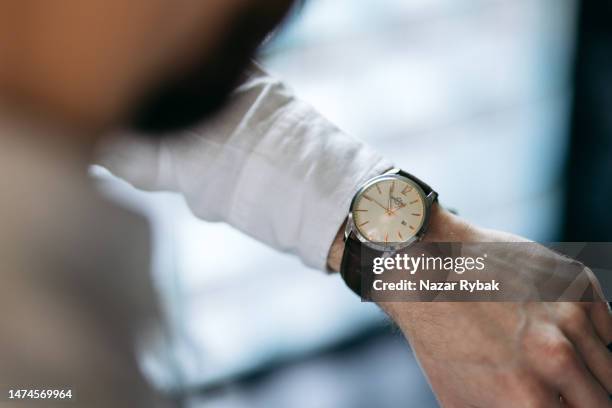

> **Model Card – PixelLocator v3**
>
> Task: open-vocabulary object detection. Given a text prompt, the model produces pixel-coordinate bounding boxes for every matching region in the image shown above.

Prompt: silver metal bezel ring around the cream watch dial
[345,173,437,252]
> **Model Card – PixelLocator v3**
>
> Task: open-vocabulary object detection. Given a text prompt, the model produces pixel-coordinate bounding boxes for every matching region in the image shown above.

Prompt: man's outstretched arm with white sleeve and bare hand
[102,66,612,407]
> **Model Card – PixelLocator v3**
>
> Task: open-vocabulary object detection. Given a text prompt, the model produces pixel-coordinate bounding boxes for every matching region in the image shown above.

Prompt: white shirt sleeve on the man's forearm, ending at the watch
[99,64,392,270]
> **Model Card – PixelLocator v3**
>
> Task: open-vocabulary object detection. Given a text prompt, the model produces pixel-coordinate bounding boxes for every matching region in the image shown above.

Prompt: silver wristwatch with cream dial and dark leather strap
[340,169,438,298]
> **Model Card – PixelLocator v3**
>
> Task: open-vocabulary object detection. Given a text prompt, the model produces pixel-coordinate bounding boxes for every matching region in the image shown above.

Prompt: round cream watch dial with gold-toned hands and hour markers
[352,175,426,245]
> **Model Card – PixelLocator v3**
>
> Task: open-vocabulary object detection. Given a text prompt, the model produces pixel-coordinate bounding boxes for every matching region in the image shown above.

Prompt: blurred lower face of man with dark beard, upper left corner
[0,0,293,131]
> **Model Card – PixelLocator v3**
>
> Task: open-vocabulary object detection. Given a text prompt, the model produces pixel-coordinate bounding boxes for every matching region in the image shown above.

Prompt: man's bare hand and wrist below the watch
[330,206,612,408]
